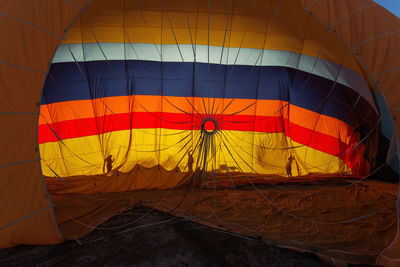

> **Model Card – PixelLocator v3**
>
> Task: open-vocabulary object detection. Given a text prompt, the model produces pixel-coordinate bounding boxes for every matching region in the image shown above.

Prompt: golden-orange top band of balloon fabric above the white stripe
[63,0,362,74]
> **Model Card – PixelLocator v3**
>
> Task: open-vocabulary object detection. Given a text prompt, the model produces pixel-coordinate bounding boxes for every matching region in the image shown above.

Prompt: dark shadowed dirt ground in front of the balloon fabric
[0,206,340,266]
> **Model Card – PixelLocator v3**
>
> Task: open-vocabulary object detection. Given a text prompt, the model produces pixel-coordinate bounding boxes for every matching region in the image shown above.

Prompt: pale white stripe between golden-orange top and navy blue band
[52,43,377,111]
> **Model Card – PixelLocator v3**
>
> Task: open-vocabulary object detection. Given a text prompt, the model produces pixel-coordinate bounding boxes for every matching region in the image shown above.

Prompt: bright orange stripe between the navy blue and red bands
[39,95,358,147]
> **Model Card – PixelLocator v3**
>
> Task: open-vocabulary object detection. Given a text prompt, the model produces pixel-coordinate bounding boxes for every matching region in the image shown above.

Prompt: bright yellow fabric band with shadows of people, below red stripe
[40,129,351,177]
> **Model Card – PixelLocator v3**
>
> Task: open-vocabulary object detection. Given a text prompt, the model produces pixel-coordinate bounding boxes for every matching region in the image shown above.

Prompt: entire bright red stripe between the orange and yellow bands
[39,112,369,175]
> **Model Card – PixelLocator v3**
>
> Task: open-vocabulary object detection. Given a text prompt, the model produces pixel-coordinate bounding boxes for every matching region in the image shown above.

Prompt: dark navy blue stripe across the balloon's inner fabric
[42,60,377,132]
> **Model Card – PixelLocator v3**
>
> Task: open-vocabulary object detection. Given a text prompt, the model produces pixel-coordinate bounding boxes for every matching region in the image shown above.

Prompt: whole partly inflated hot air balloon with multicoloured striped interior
[0,0,400,265]
